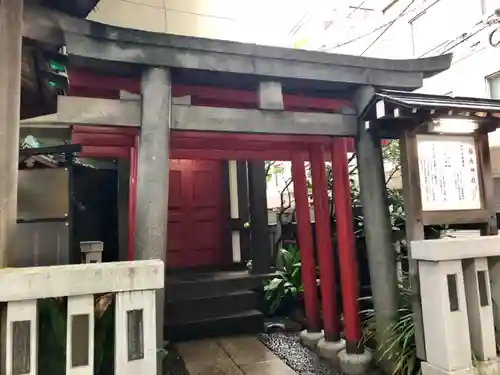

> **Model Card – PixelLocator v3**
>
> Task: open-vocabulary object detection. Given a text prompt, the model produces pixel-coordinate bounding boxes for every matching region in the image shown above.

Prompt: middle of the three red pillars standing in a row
[311,146,340,341]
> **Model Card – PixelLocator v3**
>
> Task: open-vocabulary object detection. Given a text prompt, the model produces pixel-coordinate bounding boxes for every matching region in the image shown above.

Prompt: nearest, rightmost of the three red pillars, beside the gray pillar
[332,138,363,354]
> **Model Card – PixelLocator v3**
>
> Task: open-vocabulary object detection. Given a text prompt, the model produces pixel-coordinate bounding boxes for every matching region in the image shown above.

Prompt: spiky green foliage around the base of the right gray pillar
[361,283,420,375]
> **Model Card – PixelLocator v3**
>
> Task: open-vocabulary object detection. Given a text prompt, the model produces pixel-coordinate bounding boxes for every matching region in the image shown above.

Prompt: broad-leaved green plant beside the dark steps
[264,245,304,315]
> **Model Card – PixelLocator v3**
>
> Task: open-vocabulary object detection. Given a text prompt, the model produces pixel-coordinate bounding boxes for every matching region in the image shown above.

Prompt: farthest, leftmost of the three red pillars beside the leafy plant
[292,154,321,332]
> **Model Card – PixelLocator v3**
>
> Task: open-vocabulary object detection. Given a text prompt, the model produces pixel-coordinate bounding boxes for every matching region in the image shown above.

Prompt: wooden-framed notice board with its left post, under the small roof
[400,131,498,360]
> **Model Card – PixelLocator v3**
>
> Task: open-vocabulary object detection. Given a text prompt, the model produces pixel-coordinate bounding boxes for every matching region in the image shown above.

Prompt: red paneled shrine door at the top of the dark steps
[167,159,228,268]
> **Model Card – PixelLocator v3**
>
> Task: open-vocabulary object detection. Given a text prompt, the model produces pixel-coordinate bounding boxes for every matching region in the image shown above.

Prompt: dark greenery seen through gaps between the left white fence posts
[39,294,114,375]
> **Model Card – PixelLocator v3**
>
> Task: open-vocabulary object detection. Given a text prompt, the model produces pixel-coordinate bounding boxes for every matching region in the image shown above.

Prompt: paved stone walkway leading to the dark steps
[177,336,296,375]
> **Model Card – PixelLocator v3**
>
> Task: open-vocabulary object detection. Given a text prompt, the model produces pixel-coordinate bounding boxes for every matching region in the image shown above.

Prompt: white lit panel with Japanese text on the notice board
[417,135,481,211]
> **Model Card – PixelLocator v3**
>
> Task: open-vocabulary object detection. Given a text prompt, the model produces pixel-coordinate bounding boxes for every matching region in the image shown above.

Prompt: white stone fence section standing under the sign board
[411,236,500,375]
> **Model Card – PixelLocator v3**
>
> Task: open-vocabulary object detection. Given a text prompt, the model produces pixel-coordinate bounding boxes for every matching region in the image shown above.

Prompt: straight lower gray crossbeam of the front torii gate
[21,96,357,136]
